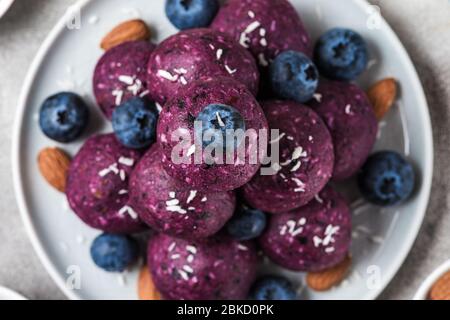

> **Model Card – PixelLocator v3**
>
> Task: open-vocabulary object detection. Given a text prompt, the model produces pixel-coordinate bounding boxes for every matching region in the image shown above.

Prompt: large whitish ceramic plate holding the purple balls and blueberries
[13,0,433,299]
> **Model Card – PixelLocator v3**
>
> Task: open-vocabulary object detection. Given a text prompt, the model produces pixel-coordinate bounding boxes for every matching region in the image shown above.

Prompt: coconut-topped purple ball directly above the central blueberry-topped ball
[147,29,259,104]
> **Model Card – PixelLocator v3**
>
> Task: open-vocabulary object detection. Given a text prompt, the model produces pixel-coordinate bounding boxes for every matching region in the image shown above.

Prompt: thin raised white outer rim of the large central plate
[11,0,434,300]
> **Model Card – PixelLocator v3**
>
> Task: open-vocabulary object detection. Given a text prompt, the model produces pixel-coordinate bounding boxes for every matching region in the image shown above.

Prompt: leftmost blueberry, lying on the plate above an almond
[39,92,89,142]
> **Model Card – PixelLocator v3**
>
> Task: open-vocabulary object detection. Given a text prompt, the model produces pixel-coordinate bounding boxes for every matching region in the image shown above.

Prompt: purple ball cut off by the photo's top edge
[211,0,312,68]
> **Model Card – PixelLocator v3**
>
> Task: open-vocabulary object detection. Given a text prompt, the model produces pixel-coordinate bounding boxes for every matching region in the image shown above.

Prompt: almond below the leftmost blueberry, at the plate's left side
[38,148,70,192]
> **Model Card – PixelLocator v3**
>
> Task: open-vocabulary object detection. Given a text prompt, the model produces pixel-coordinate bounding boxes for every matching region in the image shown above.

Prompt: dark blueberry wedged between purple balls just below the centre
[227,205,267,241]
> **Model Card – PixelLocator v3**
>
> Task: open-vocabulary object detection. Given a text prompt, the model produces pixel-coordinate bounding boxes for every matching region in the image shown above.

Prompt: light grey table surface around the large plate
[0,0,450,299]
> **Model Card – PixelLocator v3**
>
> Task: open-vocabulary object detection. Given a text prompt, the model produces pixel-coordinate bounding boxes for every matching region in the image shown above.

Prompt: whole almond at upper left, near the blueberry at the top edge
[100,19,150,50]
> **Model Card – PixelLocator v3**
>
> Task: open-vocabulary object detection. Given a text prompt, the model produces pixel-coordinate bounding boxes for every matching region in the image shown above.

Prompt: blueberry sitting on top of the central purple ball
[194,104,245,152]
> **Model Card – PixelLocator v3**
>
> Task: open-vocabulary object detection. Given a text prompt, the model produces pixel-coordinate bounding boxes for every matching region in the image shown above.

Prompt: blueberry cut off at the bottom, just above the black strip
[250,276,297,300]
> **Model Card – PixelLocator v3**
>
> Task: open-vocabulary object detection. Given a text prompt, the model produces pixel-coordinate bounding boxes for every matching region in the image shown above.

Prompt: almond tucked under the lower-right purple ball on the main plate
[306,256,352,291]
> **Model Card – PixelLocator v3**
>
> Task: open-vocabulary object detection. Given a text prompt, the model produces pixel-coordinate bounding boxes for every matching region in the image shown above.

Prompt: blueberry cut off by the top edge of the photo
[166,0,220,30]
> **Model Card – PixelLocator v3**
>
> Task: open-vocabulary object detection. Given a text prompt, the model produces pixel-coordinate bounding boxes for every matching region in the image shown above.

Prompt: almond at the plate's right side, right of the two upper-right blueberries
[367,78,397,120]
